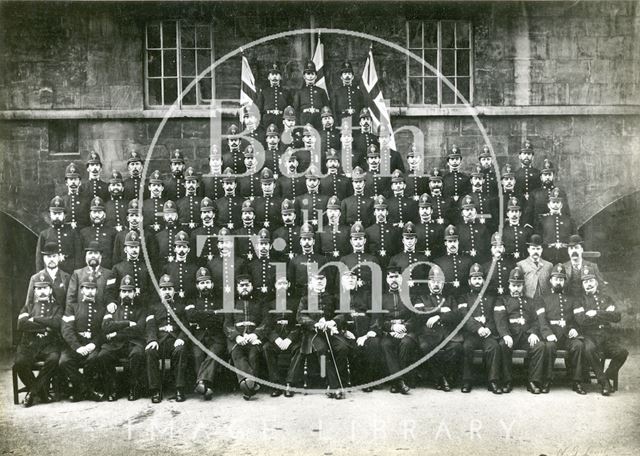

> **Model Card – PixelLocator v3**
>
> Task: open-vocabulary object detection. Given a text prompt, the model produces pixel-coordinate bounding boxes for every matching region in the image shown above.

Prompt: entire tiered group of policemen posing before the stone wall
[15,62,628,406]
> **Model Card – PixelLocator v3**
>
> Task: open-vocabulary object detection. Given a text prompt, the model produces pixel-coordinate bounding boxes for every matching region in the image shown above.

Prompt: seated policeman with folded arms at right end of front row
[573,266,629,396]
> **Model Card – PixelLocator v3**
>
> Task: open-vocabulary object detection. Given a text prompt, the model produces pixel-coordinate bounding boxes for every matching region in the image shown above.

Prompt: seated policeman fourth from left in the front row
[146,274,190,404]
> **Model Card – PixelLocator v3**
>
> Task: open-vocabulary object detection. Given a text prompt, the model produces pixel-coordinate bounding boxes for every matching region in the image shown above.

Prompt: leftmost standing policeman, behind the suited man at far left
[36,196,83,274]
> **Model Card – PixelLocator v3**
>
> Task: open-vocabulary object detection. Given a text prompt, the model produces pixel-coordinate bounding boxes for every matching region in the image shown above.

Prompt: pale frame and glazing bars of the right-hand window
[405,19,474,108]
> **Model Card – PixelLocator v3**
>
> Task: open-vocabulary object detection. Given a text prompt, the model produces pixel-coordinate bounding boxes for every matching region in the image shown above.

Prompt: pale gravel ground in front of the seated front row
[0,349,640,456]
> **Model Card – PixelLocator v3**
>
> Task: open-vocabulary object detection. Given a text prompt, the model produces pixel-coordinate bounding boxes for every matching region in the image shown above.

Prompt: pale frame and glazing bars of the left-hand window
[144,19,216,110]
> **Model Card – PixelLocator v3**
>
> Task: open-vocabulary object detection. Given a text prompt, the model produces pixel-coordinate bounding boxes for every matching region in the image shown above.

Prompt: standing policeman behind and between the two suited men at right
[536,187,576,264]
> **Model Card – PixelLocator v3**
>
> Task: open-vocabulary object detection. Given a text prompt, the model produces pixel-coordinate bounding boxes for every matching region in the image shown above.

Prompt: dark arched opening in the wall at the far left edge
[0,212,38,351]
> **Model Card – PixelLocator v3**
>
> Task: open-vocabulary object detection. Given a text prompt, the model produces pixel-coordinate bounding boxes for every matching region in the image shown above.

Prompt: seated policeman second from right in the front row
[535,263,587,394]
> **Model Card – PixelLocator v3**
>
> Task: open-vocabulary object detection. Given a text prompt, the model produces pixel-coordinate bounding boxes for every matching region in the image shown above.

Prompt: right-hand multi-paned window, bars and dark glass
[407,21,473,106]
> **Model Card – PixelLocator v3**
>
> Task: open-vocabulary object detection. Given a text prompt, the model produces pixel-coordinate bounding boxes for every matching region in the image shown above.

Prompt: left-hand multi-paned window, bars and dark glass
[145,21,214,107]
